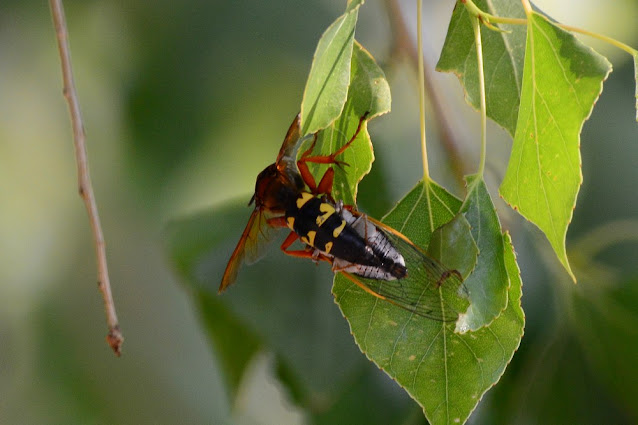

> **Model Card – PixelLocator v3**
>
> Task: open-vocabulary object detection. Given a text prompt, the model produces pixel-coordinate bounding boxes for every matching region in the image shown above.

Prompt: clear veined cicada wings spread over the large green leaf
[342,218,469,322]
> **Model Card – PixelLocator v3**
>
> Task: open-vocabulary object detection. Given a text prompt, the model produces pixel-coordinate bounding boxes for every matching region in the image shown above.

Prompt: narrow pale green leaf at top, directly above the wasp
[301,1,363,135]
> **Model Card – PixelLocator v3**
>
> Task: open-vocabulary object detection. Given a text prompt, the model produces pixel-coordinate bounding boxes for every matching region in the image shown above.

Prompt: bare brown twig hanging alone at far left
[49,0,124,356]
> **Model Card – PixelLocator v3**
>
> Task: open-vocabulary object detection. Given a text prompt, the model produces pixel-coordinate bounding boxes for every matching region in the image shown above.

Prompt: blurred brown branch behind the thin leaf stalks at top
[385,0,466,187]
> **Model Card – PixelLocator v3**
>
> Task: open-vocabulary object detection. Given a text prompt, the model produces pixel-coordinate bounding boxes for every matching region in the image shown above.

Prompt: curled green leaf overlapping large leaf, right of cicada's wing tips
[458,175,510,331]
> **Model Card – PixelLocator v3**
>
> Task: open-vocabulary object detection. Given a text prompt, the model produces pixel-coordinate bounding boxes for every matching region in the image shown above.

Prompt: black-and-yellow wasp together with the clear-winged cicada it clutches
[219,114,467,321]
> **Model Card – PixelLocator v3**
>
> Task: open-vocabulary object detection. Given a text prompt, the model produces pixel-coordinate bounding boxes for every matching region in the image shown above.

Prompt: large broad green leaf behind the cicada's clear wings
[333,183,524,424]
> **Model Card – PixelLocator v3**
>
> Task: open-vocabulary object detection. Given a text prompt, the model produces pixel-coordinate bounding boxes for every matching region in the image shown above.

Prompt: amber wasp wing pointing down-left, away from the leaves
[219,208,279,293]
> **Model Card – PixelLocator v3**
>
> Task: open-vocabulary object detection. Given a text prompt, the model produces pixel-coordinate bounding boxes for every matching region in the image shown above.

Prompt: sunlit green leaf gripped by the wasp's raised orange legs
[299,43,391,205]
